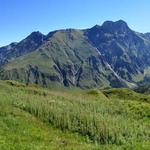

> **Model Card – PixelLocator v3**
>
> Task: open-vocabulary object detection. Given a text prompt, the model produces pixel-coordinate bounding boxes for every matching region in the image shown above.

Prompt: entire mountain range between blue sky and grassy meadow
[0,20,150,88]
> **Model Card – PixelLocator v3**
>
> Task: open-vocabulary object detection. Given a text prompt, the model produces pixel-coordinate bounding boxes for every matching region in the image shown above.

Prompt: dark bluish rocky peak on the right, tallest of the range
[85,20,150,82]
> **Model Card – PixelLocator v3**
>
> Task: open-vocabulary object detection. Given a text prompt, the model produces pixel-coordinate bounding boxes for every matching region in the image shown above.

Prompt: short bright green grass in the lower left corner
[0,106,94,150]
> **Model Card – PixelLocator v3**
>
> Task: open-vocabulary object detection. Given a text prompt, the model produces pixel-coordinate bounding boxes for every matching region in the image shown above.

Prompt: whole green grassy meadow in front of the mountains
[0,81,150,150]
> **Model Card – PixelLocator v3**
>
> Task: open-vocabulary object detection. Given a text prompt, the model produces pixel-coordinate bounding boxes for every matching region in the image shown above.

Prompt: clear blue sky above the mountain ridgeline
[0,0,150,46]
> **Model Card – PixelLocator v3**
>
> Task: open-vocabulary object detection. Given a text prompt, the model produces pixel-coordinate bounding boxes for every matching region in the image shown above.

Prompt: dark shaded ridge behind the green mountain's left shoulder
[0,32,45,65]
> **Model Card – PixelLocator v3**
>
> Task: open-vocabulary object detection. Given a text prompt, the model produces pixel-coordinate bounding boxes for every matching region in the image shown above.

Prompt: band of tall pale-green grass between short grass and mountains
[0,81,150,145]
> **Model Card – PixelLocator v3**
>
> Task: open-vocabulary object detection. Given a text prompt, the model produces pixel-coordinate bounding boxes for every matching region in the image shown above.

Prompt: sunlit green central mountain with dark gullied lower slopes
[0,29,125,88]
